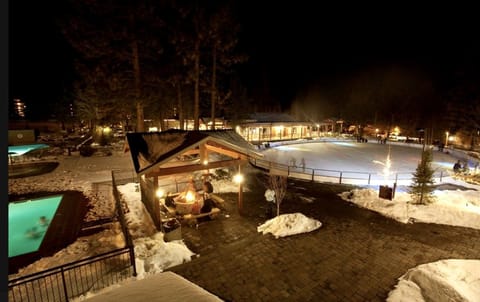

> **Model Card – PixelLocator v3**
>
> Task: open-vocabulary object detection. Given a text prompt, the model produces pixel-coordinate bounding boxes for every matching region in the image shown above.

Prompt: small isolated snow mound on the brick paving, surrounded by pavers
[257,213,322,238]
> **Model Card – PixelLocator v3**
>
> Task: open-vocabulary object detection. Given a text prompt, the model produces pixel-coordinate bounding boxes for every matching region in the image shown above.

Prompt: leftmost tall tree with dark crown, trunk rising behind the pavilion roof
[58,0,164,132]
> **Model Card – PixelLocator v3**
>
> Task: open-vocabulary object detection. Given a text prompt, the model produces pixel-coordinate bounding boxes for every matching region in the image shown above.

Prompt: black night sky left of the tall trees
[9,0,73,117]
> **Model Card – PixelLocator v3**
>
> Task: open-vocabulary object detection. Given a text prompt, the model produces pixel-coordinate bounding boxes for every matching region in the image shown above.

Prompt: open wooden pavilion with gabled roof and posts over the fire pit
[126,129,262,230]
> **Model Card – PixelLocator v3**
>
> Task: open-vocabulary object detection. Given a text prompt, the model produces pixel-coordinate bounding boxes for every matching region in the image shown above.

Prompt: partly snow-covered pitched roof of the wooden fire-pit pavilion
[127,129,261,174]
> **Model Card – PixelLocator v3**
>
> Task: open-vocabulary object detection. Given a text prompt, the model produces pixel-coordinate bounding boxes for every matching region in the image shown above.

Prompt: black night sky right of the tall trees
[237,1,480,108]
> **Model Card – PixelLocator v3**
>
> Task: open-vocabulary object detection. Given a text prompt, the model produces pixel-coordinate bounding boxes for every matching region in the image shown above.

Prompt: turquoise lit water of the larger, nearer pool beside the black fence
[8,195,63,258]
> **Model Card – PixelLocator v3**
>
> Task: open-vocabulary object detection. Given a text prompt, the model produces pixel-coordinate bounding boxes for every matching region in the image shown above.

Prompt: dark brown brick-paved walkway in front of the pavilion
[170,171,480,301]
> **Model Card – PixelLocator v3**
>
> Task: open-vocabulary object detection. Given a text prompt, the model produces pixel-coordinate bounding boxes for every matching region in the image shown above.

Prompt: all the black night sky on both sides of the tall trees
[9,0,480,118]
